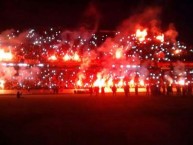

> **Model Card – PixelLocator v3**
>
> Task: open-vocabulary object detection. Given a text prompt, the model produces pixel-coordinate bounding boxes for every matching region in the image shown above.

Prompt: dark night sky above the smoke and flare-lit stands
[0,0,193,44]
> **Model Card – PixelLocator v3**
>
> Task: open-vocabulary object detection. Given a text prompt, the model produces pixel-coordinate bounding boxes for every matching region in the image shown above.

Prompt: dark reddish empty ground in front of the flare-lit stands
[0,94,193,145]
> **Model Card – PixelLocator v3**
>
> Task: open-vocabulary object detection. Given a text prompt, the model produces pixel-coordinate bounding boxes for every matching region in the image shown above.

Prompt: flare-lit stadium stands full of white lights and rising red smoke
[0,9,193,94]
